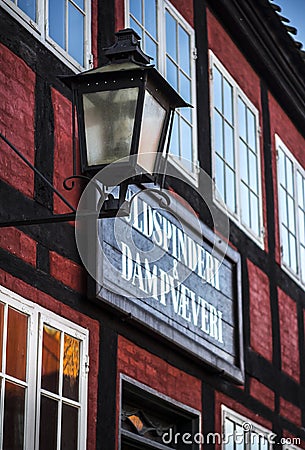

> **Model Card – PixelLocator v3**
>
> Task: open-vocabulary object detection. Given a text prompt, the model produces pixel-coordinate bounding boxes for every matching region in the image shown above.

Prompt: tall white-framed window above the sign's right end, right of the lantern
[211,53,263,246]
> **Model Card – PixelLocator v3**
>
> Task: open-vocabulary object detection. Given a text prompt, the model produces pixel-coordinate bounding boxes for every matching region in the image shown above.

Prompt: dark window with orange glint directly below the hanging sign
[120,375,200,450]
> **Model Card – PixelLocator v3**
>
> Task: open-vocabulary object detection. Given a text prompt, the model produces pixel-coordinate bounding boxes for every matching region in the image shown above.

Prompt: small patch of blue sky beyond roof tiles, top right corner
[274,0,305,50]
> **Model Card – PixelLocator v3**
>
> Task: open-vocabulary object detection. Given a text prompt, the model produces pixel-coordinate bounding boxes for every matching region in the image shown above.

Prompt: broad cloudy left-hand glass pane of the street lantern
[83,87,139,166]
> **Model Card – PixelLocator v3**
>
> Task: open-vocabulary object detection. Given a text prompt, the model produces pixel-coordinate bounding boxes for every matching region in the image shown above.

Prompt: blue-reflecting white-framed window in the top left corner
[0,0,90,69]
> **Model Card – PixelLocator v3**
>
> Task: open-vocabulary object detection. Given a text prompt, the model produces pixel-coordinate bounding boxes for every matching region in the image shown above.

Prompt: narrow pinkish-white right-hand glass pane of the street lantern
[138,91,166,173]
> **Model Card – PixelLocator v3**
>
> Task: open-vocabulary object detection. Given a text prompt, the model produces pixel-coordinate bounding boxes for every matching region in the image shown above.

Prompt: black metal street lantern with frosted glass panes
[64,29,188,185]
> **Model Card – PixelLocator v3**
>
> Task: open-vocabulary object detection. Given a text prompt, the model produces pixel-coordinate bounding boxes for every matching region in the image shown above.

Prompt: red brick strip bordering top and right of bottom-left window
[0,269,99,450]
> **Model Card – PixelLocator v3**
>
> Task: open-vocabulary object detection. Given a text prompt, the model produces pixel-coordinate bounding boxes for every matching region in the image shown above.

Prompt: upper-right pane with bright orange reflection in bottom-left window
[63,334,80,401]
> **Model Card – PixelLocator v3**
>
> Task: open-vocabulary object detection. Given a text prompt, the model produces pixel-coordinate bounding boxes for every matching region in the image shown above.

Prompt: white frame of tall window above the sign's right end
[209,50,265,249]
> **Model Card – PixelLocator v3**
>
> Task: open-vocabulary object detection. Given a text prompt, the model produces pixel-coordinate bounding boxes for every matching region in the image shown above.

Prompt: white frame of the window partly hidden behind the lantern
[125,0,199,186]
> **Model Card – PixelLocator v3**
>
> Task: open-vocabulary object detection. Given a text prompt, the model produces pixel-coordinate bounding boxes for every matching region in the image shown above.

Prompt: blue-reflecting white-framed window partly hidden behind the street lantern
[126,0,198,181]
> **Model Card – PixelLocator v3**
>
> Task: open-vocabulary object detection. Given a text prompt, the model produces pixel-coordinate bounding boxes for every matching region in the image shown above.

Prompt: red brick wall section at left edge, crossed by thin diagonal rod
[0,44,35,197]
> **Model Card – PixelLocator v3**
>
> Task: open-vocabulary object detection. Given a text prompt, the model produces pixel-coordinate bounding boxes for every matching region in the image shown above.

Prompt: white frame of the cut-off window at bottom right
[221,405,274,450]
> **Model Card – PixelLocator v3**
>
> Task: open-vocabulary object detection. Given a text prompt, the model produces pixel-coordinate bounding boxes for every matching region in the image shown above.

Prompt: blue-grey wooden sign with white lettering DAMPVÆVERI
[96,187,243,381]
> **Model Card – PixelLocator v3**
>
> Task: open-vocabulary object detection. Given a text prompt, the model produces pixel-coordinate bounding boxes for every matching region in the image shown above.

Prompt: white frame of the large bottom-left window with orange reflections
[0,286,89,450]
